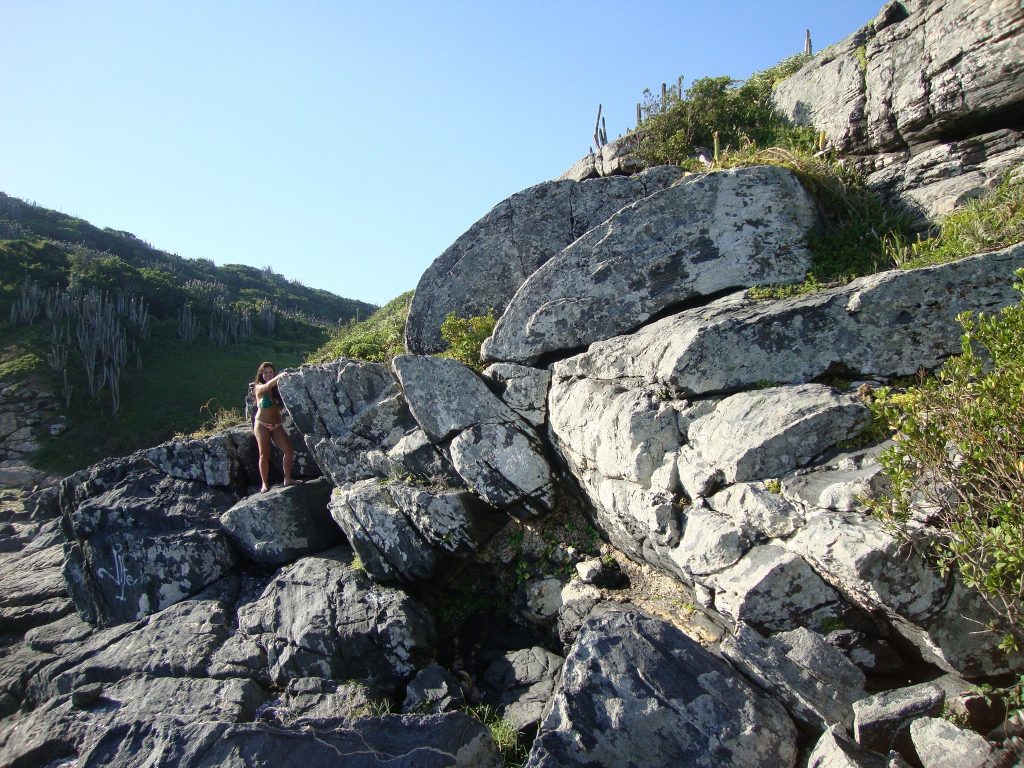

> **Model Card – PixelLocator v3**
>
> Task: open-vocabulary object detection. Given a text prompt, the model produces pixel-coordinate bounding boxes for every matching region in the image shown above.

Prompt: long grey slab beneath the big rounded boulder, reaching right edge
[554,245,1024,395]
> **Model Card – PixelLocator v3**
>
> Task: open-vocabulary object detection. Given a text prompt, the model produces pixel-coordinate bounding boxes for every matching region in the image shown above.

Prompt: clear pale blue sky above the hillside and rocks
[0,0,883,304]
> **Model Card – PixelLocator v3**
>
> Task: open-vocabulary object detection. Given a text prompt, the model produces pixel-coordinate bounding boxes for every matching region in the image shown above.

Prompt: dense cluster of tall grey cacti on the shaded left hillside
[11,276,150,416]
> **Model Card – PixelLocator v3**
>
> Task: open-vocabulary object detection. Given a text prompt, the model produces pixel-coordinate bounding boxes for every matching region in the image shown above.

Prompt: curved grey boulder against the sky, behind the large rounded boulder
[406,168,682,354]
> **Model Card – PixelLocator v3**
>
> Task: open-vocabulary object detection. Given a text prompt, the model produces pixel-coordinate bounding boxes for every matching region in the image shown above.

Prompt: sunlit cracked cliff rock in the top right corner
[774,0,1024,153]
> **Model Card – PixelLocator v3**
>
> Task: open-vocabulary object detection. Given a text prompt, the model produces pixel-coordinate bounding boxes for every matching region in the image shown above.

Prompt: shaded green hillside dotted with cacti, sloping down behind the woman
[0,194,377,474]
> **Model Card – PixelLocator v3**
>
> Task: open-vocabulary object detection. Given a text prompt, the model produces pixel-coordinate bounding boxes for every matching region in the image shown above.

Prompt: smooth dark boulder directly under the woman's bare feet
[220,478,343,565]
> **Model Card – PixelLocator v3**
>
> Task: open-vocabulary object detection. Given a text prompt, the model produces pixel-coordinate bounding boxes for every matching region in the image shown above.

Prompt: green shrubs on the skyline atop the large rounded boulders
[636,54,816,171]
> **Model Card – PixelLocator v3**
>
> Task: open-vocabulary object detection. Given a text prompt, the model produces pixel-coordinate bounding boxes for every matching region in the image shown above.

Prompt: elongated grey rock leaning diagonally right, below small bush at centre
[392,355,554,517]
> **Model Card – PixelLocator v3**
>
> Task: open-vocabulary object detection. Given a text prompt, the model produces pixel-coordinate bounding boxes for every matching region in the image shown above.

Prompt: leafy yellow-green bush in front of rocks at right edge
[871,270,1024,648]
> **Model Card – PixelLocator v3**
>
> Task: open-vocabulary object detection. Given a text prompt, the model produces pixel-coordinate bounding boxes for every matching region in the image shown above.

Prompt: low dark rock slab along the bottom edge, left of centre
[80,712,504,768]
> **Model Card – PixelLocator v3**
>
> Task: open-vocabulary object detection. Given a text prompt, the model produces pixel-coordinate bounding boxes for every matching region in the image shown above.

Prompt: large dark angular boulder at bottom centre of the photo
[526,610,797,768]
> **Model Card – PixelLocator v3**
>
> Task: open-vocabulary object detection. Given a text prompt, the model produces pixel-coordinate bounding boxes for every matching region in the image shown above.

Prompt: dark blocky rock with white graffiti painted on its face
[63,470,237,626]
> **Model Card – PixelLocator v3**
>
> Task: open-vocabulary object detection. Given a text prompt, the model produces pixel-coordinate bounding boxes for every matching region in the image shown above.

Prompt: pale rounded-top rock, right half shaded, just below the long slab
[679,384,870,498]
